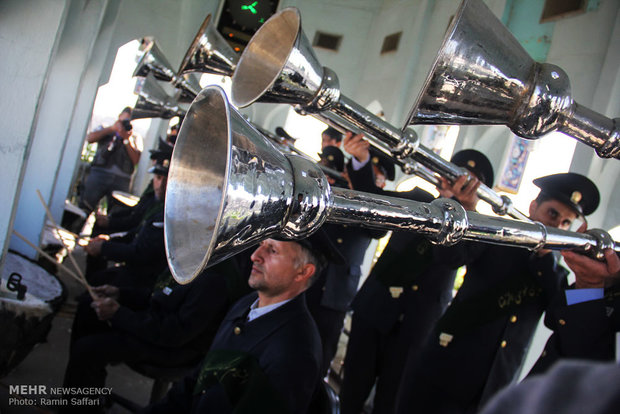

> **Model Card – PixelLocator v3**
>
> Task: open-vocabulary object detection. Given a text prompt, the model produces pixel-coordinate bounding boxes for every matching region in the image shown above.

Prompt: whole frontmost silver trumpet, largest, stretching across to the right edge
[164,86,619,283]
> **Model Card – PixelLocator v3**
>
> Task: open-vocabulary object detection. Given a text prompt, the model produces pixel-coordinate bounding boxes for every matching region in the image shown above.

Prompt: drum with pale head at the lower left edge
[0,252,65,378]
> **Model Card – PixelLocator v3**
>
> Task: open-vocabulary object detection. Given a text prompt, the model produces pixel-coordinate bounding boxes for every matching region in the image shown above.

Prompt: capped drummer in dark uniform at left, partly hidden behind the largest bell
[84,153,171,287]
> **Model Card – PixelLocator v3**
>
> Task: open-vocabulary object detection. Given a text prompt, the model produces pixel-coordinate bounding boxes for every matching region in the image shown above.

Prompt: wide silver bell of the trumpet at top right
[407,0,534,128]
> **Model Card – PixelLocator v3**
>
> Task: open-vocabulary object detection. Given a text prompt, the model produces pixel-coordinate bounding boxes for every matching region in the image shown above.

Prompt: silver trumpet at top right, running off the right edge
[407,0,620,158]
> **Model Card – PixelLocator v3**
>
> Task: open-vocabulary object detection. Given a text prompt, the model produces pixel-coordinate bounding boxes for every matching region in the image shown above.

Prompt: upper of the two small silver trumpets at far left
[133,41,201,102]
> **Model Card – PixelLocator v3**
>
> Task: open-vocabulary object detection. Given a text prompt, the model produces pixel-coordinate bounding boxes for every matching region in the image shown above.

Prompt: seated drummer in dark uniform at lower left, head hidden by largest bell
[58,255,249,413]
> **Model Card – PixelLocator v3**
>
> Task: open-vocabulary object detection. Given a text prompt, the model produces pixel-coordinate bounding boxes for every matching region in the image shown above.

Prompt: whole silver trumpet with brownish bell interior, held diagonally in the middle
[231,8,528,220]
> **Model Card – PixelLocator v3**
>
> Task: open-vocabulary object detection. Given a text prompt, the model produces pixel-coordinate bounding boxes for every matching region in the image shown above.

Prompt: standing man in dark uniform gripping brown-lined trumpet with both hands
[340,135,493,414]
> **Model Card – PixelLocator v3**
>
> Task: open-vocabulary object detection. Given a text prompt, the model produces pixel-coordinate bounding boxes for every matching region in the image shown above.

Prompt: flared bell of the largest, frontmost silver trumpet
[165,86,295,283]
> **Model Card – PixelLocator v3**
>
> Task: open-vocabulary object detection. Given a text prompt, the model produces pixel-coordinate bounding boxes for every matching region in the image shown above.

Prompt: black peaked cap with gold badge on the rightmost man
[533,173,601,216]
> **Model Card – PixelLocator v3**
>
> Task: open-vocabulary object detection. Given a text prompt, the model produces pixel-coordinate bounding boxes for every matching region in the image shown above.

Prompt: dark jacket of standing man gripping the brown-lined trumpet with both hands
[349,158,458,333]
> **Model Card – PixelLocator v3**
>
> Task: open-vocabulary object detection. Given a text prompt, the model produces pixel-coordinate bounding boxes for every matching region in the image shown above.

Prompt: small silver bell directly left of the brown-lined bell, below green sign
[177,14,239,76]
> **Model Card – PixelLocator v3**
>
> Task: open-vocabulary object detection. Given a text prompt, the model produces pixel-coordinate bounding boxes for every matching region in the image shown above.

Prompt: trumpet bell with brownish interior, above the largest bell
[231,8,324,107]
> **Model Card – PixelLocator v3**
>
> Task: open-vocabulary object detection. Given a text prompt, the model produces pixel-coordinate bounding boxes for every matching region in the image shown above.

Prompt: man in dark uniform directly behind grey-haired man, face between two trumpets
[306,145,385,375]
